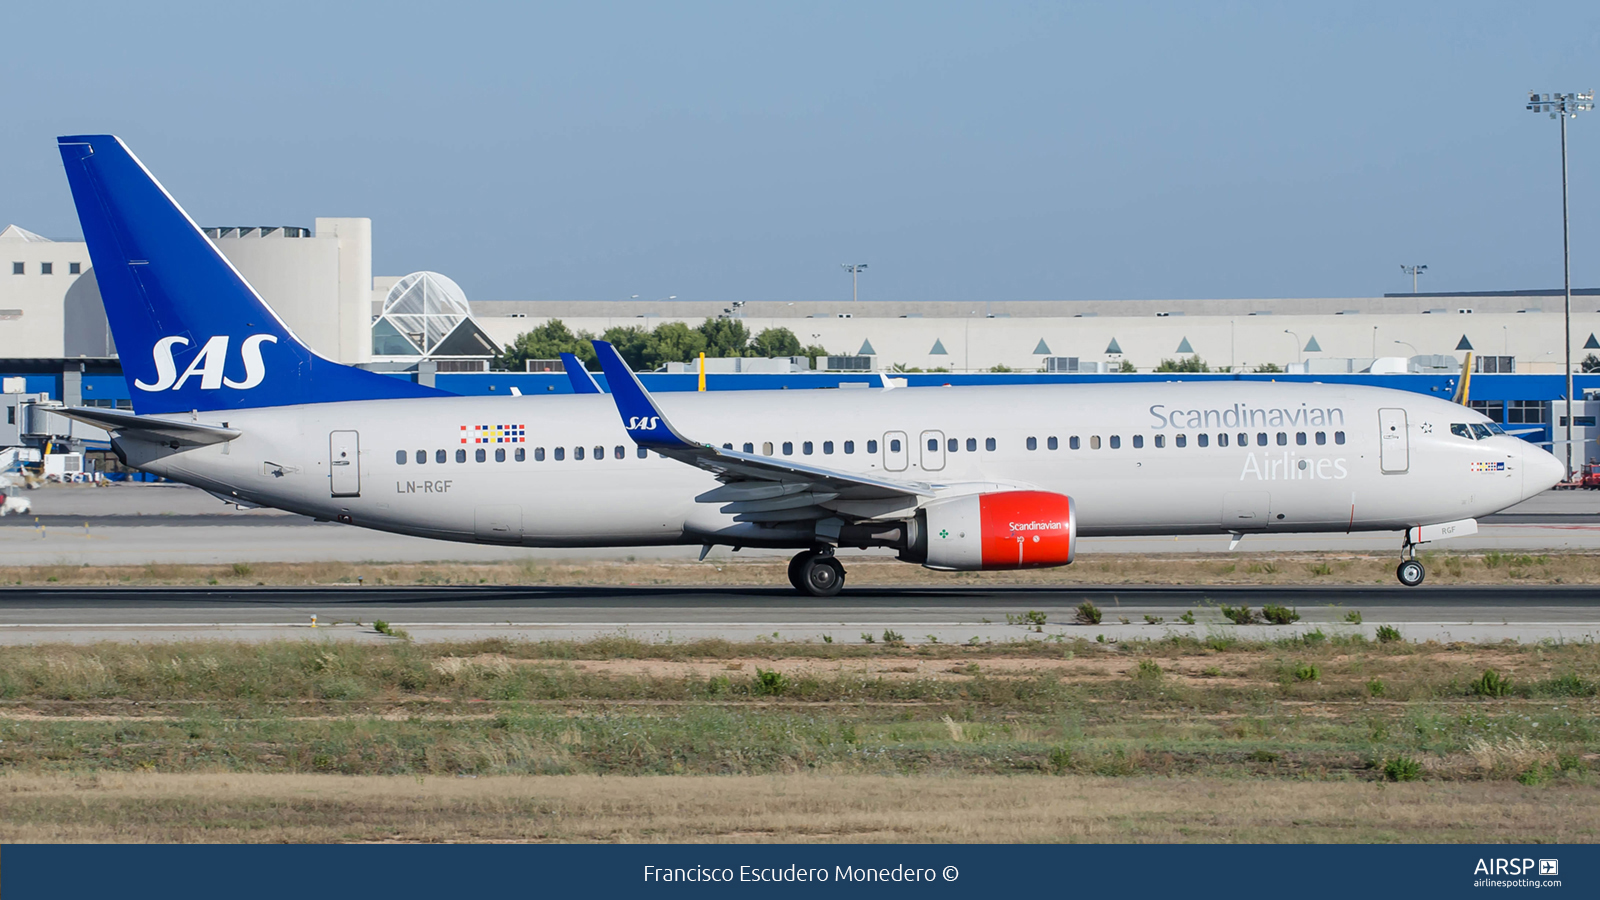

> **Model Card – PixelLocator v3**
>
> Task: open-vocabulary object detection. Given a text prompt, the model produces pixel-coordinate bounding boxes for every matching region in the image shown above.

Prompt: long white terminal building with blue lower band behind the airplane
[0,218,1600,458]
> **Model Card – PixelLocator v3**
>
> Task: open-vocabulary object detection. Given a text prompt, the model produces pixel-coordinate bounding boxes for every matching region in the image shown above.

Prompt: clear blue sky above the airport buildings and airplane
[0,2,1600,301]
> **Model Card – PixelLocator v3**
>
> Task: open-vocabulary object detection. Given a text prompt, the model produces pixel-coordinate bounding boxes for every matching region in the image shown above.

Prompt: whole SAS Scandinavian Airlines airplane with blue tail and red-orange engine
[58,135,1563,597]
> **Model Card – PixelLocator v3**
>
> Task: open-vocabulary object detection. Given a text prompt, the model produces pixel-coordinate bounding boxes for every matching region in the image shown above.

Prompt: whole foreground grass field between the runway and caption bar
[0,633,1600,841]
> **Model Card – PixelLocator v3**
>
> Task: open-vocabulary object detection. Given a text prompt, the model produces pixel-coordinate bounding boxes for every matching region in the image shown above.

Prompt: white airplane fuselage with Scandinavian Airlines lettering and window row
[118,381,1562,546]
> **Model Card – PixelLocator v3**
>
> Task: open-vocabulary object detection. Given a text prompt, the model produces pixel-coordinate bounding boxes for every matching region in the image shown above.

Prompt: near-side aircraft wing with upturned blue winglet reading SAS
[594,334,934,522]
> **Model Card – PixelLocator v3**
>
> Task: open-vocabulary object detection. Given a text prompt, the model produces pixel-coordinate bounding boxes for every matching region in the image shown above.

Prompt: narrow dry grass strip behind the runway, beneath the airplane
[9,552,1600,588]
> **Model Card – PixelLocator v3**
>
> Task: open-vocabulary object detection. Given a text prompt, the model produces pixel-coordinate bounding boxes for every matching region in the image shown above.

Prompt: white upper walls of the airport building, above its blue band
[0,218,1600,373]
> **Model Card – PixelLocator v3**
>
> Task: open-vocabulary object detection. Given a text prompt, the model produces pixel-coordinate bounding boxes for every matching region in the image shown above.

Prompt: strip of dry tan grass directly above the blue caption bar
[0,773,1600,842]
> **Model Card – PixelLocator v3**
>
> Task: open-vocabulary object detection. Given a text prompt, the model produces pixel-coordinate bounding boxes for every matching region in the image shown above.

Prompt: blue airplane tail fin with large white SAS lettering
[56,135,448,413]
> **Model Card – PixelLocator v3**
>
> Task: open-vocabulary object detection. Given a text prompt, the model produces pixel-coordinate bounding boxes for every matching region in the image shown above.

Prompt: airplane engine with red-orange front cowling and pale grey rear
[904,490,1078,570]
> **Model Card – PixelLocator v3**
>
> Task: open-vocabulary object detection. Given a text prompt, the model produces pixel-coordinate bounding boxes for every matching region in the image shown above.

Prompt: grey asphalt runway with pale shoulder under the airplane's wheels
[0,586,1600,644]
